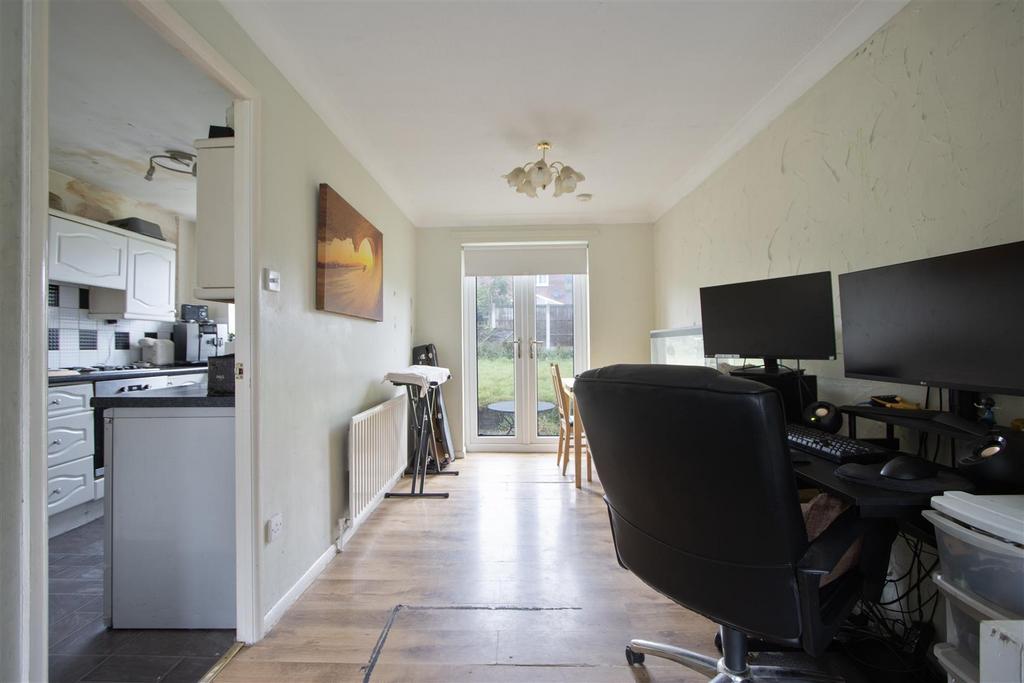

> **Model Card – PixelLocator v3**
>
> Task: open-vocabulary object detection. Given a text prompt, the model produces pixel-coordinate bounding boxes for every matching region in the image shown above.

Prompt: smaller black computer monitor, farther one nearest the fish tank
[700,271,836,373]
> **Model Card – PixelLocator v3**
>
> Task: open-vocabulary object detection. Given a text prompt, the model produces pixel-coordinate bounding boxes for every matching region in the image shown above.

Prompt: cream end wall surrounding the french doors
[416,224,654,451]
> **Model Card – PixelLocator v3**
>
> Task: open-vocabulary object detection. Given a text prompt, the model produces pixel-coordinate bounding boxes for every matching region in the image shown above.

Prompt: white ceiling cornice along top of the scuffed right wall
[650,0,909,221]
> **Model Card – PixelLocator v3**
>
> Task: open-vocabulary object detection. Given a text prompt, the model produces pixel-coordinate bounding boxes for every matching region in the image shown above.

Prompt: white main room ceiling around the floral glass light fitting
[225,0,905,226]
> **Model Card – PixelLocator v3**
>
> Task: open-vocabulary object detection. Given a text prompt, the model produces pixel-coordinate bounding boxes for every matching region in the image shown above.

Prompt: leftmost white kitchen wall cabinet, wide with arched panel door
[48,211,128,290]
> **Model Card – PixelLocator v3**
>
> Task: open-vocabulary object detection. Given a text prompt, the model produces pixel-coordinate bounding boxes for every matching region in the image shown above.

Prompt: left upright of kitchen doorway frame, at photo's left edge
[0,0,49,681]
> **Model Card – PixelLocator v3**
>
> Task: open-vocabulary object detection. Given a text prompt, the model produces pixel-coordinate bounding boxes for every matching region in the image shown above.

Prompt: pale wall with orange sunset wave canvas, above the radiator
[172,0,415,613]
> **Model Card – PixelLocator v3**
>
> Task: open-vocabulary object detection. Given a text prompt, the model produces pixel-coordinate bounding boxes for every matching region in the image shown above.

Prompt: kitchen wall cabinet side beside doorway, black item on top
[194,137,234,301]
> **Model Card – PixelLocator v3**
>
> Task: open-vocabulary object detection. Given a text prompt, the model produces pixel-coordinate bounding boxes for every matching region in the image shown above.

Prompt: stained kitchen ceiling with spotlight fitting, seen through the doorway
[49,0,231,218]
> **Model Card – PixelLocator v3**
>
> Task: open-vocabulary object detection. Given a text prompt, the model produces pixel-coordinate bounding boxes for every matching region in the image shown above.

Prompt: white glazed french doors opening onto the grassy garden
[463,274,589,452]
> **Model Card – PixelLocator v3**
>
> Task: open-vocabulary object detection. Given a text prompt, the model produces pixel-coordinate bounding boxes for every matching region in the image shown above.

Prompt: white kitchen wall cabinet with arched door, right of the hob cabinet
[89,232,177,321]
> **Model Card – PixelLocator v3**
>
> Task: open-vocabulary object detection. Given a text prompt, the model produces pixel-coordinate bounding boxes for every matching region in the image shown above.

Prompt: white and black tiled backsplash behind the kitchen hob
[46,285,174,369]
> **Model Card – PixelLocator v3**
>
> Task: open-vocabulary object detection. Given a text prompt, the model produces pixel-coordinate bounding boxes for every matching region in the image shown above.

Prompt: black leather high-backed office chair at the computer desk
[573,366,861,683]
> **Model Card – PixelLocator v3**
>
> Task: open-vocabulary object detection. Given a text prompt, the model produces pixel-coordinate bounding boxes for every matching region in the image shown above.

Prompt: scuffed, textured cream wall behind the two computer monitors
[654,0,1024,422]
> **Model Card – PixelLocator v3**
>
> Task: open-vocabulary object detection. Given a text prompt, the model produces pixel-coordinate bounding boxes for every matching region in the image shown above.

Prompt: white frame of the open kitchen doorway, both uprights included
[9,0,263,680]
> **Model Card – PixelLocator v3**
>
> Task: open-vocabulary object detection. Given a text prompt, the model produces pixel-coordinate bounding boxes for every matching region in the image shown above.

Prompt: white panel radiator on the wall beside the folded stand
[339,394,409,546]
